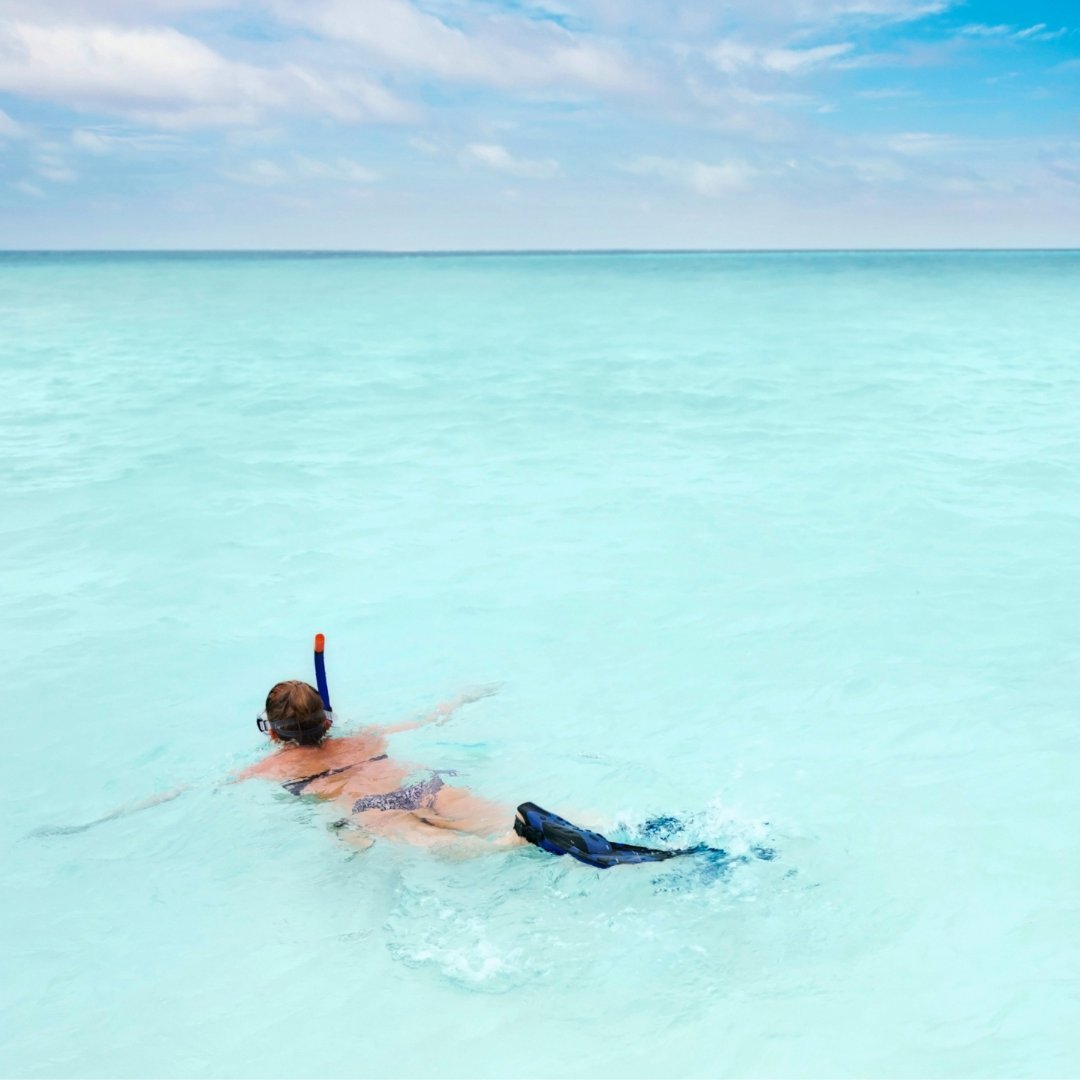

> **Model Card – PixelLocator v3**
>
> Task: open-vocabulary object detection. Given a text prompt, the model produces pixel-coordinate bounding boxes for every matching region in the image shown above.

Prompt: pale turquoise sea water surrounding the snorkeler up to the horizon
[0,253,1080,1077]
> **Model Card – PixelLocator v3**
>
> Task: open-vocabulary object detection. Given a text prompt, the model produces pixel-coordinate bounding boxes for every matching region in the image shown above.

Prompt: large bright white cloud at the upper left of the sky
[0,23,407,129]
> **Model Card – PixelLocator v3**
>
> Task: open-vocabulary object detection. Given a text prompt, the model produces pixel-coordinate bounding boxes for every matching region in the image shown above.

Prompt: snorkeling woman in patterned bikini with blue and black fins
[235,634,702,869]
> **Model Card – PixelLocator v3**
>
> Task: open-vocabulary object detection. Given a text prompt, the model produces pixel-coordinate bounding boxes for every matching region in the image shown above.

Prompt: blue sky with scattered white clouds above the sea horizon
[0,0,1080,251]
